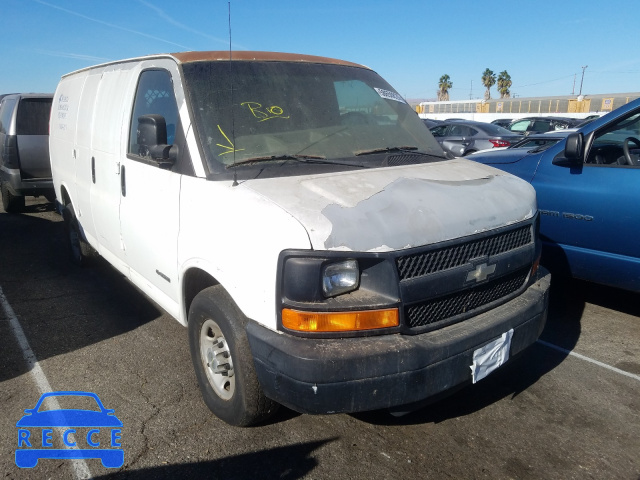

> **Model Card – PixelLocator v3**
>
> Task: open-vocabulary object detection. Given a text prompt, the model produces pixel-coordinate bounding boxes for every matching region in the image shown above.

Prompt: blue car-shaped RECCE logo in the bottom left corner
[15,391,124,468]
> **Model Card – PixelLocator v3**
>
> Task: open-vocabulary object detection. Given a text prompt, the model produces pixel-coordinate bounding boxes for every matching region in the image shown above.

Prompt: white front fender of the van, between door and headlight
[178,176,311,330]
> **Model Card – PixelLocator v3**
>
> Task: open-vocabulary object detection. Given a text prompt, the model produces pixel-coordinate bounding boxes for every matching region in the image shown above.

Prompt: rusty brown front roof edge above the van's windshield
[171,50,368,68]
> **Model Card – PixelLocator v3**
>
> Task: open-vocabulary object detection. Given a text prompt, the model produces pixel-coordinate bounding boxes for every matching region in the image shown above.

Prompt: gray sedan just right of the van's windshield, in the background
[430,120,522,157]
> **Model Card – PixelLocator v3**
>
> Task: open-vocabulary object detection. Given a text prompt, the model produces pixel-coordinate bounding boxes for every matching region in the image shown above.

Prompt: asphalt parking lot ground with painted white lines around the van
[0,200,640,479]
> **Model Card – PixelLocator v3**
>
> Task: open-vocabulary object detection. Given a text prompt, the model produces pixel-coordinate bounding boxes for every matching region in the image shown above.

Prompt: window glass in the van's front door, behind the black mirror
[127,70,180,155]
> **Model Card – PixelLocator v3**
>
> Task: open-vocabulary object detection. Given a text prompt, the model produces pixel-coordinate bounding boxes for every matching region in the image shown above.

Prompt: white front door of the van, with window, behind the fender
[120,60,181,317]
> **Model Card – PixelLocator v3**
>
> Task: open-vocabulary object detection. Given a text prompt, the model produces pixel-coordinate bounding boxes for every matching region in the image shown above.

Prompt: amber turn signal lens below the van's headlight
[282,308,400,332]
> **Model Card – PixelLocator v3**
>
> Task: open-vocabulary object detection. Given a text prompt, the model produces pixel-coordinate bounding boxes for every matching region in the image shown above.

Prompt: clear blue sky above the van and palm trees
[0,0,640,100]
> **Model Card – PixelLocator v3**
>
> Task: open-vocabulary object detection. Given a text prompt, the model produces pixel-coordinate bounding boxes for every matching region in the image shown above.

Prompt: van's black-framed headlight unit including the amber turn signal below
[276,250,400,338]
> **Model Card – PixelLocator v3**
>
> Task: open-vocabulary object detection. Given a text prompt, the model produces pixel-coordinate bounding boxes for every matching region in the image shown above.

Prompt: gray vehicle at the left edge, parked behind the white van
[0,93,55,212]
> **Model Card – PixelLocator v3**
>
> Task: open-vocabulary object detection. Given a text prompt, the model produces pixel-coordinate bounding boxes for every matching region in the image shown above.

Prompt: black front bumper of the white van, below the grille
[247,268,551,413]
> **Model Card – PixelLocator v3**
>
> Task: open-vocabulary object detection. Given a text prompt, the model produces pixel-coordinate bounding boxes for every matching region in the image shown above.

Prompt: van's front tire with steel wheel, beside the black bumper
[189,285,278,427]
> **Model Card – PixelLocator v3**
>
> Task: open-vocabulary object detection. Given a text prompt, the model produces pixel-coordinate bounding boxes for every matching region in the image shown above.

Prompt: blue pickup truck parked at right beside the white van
[468,99,640,292]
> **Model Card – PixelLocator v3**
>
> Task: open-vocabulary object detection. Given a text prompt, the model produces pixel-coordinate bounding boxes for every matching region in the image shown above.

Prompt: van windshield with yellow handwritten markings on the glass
[178,61,444,173]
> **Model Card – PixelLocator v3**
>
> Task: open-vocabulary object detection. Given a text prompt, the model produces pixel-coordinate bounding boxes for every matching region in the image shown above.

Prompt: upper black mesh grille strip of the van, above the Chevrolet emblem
[396,225,533,280]
